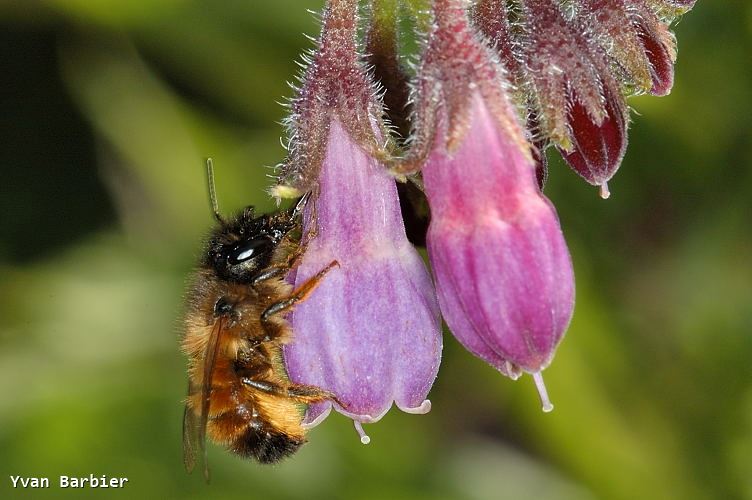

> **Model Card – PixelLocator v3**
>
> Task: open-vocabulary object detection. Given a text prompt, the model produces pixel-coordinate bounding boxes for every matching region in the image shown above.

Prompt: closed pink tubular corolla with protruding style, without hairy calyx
[423,94,574,410]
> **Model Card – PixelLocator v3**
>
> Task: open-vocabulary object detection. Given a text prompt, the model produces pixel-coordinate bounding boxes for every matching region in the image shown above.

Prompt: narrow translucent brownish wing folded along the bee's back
[183,317,225,483]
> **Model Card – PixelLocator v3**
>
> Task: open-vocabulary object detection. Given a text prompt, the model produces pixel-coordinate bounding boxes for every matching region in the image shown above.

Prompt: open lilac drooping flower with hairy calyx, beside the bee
[275,0,442,443]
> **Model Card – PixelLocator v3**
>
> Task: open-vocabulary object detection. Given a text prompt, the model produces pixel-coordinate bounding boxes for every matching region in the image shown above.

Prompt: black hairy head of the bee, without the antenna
[204,207,301,283]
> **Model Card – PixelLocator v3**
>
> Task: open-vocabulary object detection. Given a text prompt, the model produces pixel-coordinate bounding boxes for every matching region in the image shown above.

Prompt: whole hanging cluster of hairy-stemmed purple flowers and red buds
[272,0,694,442]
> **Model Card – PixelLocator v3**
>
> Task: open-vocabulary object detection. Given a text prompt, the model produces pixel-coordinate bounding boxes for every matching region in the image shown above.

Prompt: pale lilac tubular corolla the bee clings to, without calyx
[285,119,441,442]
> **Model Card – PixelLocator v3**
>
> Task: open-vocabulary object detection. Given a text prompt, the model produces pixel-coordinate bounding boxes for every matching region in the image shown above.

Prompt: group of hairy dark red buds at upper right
[473,0,694,197]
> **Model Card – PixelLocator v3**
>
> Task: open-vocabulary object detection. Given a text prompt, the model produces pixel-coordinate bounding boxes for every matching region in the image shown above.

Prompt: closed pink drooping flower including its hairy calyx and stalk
[395,0,574,410]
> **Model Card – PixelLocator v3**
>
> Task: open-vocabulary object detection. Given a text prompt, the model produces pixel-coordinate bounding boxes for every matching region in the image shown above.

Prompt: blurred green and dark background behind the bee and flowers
[0,0,752,499]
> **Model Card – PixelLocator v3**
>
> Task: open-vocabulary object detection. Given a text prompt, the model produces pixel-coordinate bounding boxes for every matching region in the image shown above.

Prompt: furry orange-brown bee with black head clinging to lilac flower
[182,159,338,481]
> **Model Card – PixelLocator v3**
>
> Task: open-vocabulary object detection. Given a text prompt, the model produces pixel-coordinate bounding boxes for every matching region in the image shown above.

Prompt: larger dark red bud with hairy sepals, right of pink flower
[523,0,629,196]
